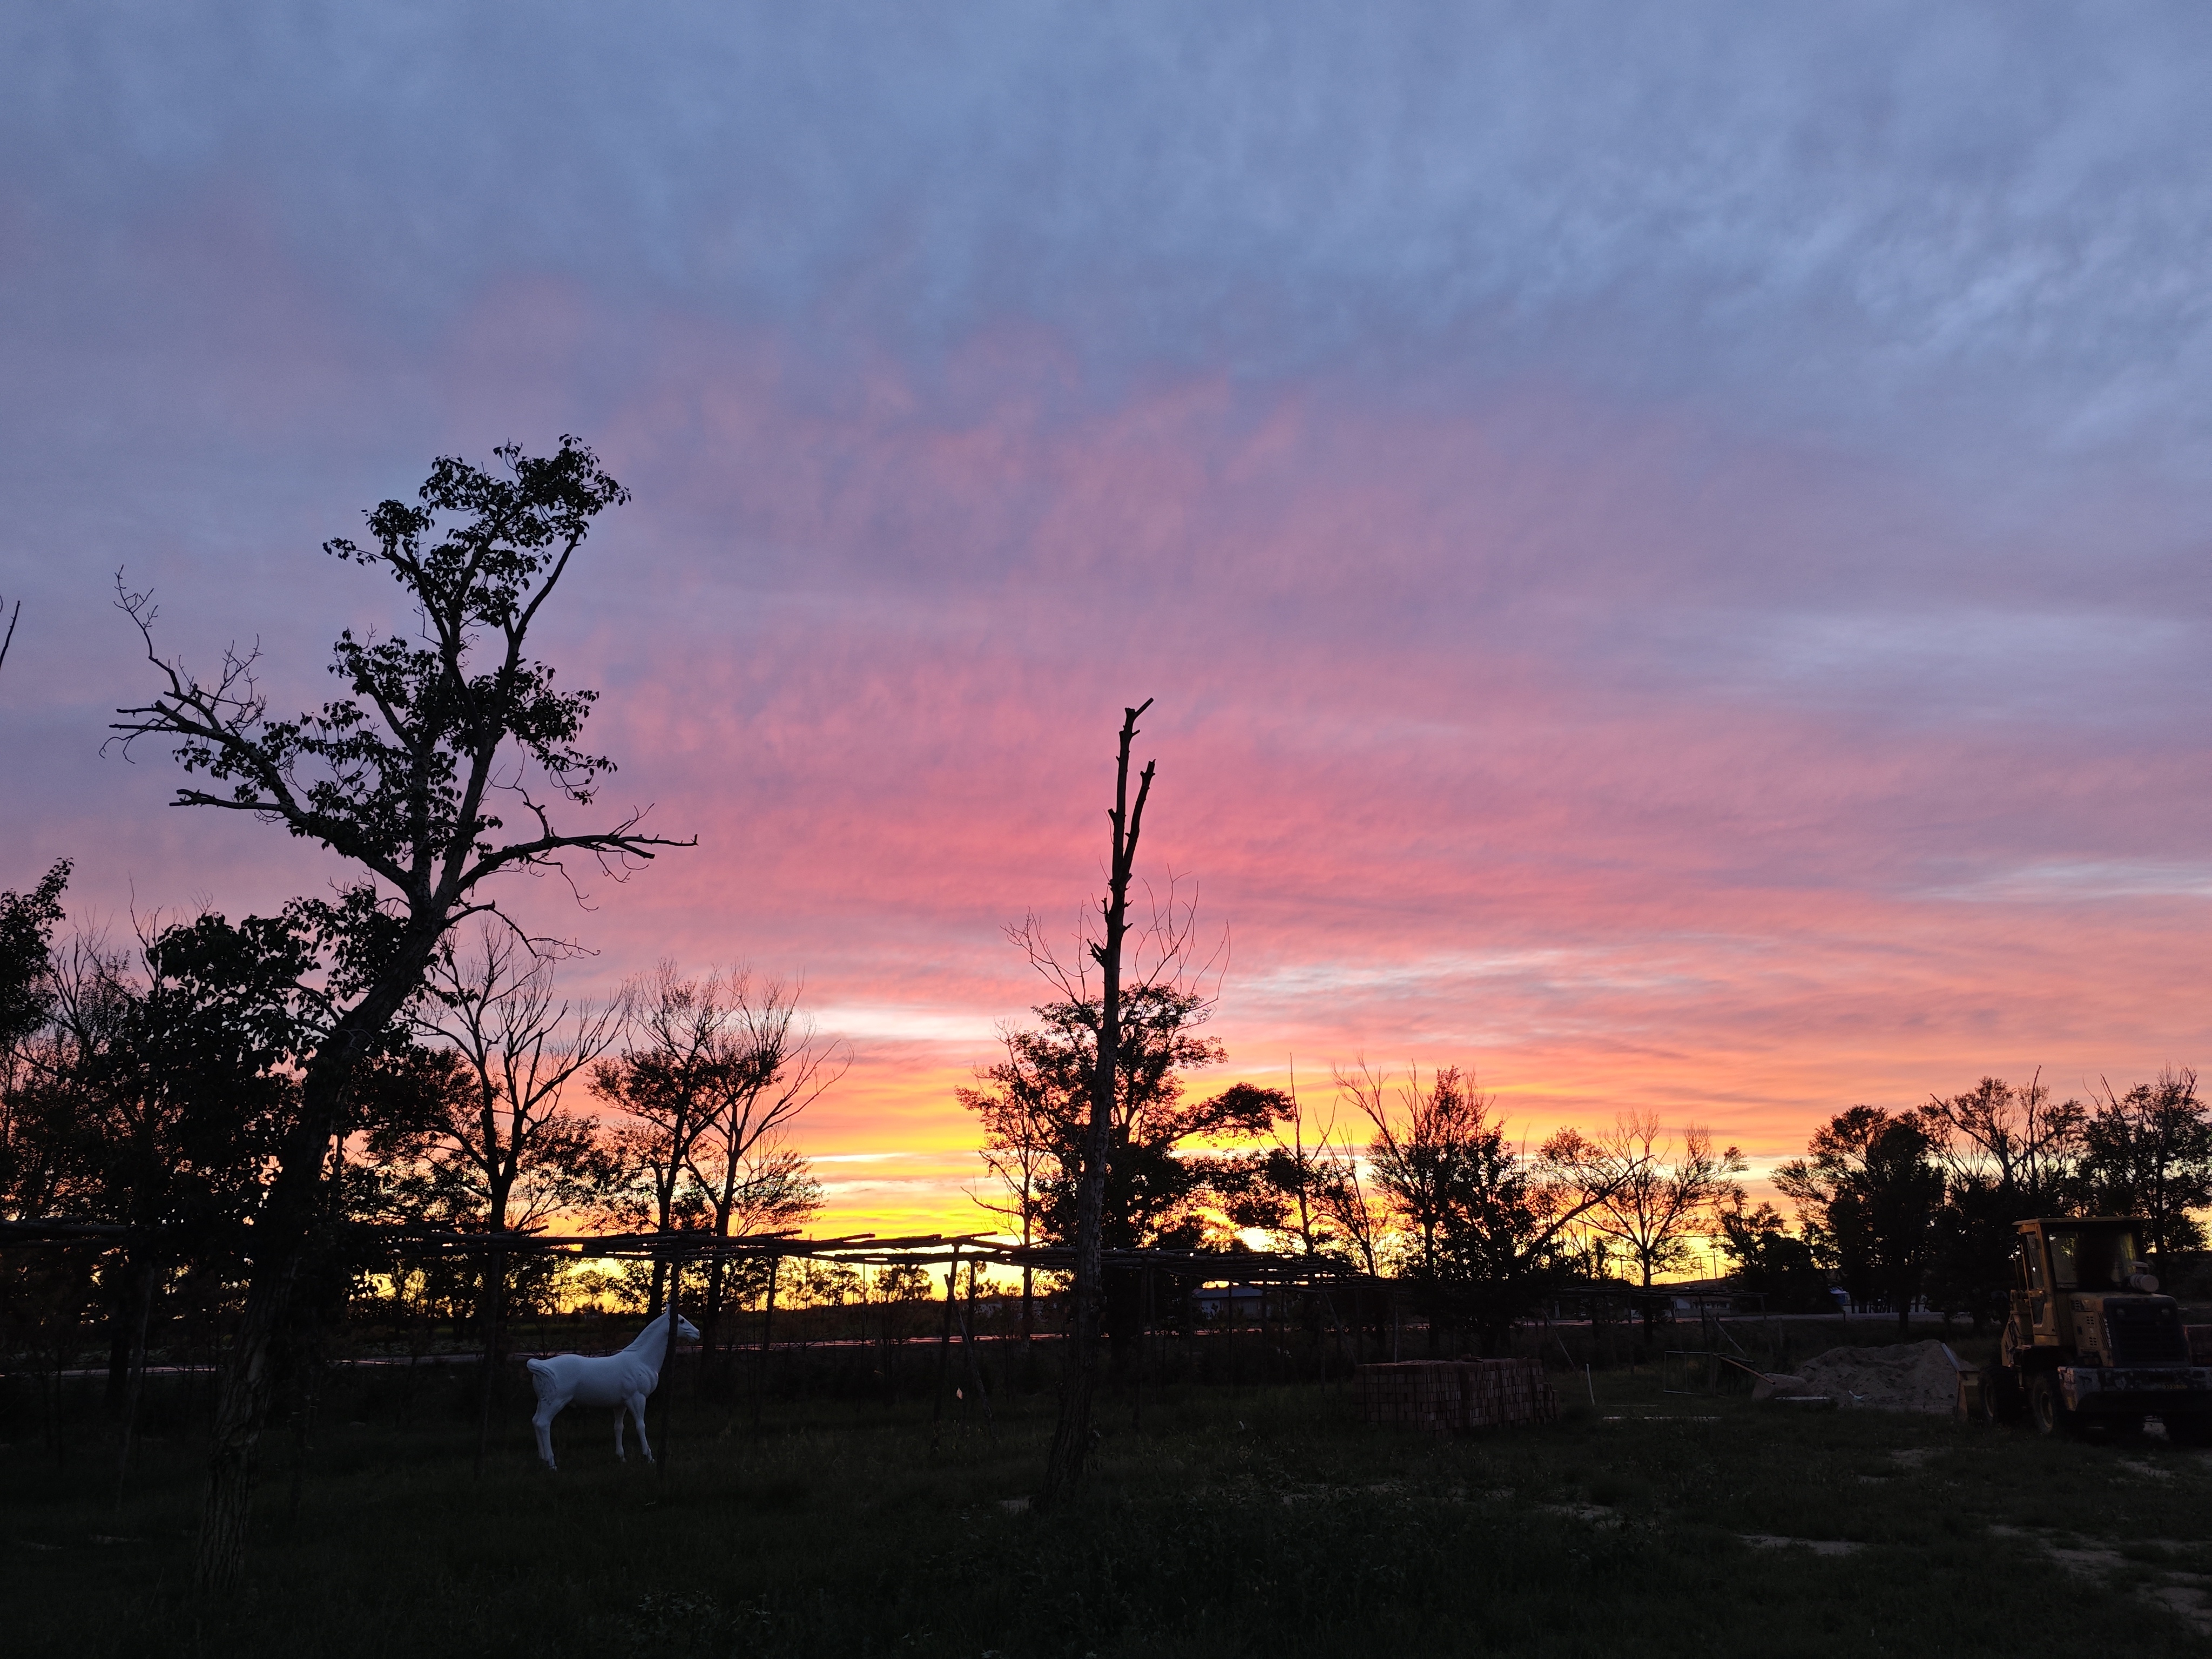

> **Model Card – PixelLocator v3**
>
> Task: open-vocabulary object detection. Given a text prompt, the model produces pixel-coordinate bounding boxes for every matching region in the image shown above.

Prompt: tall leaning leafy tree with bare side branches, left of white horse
[115,438,688,1590]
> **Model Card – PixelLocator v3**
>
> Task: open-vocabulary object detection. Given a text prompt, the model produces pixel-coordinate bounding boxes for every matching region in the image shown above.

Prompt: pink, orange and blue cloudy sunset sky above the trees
[0,0,2212,1230]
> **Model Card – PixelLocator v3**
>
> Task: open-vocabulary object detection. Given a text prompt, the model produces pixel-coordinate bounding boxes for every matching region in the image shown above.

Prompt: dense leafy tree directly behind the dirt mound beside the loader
[1774,1106,1944,1332]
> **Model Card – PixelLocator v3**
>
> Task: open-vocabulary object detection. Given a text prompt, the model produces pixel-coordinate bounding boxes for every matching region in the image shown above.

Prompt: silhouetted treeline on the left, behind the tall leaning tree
[0,865,845,1380]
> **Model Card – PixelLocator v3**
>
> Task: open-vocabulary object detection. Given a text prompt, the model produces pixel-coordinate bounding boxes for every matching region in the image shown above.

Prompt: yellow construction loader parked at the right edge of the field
[1978,1217,2212,1447]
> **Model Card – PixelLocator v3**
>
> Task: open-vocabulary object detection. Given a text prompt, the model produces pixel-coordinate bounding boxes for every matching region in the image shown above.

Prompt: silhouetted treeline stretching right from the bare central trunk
[960,982,2212,1343]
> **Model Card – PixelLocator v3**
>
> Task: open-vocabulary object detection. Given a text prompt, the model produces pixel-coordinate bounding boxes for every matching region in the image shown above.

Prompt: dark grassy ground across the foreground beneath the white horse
[13,1376,2212,1659]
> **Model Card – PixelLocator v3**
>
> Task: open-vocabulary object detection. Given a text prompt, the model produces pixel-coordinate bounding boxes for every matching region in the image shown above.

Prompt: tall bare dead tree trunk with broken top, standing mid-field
[1044,697,1152,1504]
